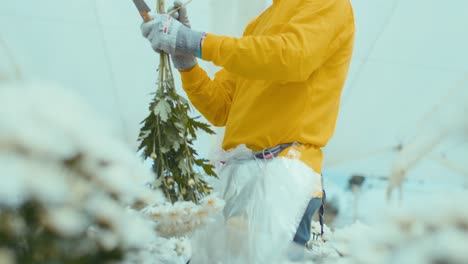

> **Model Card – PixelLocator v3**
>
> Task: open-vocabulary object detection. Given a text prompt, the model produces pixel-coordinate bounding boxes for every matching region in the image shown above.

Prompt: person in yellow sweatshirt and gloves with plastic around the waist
[142,0,355,263]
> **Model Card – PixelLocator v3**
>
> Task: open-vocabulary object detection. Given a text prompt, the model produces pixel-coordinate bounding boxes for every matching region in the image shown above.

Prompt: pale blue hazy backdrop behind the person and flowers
[0,0,468,226]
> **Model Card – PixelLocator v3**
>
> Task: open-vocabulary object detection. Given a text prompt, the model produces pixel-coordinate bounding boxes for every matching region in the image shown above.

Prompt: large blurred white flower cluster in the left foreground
[0,84,172,263]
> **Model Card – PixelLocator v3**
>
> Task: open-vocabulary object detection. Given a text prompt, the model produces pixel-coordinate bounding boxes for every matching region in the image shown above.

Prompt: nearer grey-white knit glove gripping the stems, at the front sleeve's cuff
[141,13,205,60]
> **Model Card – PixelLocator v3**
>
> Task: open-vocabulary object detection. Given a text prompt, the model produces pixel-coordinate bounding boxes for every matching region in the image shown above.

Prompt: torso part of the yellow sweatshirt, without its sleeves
[223,0,354,173]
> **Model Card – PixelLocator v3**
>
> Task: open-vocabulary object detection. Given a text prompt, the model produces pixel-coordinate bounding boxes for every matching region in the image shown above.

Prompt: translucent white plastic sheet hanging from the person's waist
[191,146,321,264]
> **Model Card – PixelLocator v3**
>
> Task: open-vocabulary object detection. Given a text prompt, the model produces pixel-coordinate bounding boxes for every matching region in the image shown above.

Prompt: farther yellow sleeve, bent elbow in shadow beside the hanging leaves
[180,64,236,126]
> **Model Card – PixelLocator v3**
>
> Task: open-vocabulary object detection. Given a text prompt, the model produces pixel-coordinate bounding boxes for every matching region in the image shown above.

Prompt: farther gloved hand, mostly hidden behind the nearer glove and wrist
[167,0,197,70]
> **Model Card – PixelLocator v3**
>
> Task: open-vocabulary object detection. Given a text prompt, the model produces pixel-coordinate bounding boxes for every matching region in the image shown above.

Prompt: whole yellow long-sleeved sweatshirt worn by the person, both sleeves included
[181,0,355,173]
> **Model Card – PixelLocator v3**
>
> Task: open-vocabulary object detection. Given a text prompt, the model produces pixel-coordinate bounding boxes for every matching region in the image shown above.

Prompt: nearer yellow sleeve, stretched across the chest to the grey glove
[202,0,352,81]
